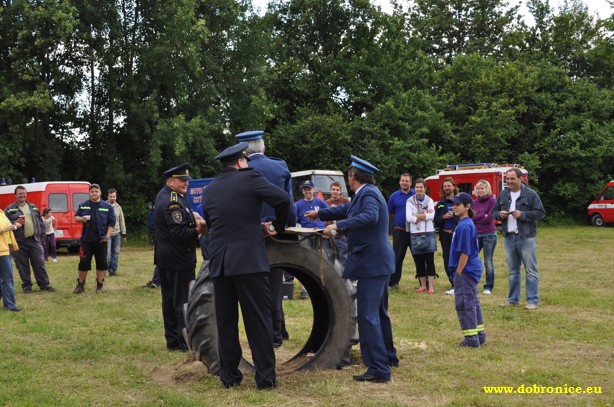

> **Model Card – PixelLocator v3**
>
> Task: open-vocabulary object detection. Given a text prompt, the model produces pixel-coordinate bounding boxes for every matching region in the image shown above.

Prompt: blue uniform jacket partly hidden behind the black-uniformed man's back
[249,154,296,226]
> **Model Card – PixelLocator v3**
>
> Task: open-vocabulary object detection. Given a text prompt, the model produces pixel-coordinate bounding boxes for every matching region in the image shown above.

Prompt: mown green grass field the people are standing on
[0,227,614,406]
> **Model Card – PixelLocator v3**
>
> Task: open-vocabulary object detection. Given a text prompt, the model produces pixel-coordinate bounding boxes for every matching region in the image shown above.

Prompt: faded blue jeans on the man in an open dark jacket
[504,233,539,304]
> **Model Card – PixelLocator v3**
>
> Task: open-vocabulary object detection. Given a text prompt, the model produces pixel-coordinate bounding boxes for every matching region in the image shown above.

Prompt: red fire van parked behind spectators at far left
[0,181,90,252]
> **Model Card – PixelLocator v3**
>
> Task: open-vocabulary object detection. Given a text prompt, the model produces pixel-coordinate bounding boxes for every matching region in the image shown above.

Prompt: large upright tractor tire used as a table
[184,235,358,374]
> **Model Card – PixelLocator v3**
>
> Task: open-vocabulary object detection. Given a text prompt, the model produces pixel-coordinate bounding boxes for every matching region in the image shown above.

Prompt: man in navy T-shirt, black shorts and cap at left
[73,184,115,294]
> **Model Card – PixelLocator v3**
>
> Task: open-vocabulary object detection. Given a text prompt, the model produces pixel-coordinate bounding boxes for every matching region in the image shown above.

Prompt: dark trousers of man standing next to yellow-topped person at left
[11,238,49,290]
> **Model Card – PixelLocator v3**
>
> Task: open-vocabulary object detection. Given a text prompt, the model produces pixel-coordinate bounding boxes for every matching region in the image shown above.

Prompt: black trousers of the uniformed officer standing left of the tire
[158,267,194,350]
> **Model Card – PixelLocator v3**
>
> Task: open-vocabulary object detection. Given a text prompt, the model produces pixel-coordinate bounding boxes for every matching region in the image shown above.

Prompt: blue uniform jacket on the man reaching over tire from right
[318,184,394,279]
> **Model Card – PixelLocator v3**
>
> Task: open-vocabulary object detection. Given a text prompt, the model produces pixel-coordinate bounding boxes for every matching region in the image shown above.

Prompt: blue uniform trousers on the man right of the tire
[356,275,399,379]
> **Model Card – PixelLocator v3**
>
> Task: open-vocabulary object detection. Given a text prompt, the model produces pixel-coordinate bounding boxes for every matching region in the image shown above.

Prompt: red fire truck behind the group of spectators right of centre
[424,163,529,202]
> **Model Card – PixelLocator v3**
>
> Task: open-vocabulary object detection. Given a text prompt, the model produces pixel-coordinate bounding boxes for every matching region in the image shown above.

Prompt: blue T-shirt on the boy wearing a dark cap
[448,217,482,283]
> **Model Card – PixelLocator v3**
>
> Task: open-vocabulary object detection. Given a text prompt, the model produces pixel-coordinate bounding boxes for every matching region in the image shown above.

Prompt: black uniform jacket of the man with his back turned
[205,168,290,278]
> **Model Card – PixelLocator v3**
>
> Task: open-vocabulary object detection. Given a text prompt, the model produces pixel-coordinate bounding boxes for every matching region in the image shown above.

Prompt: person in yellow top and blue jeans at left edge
[0,209,21,312]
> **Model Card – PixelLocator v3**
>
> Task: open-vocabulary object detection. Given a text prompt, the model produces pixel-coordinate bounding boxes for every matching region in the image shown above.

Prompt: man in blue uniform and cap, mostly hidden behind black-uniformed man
[235,130,296,347]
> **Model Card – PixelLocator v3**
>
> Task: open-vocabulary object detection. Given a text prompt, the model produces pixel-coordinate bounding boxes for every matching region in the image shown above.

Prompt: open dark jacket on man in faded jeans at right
[492,185,546,238]
